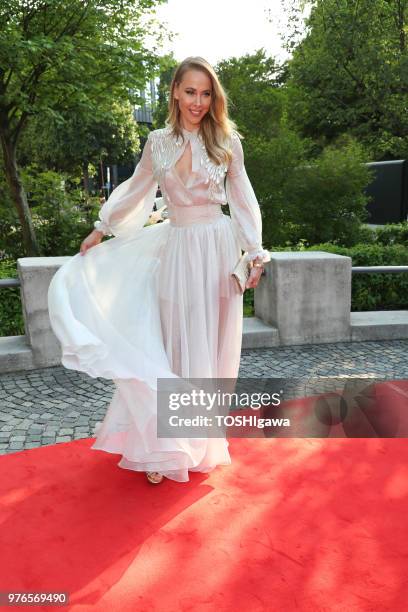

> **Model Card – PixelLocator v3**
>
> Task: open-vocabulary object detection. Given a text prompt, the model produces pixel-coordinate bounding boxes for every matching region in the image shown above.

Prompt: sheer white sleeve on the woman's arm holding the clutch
[225,134,271,262]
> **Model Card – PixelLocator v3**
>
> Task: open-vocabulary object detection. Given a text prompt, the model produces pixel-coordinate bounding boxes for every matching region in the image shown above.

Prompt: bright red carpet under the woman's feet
[0,438,408,612]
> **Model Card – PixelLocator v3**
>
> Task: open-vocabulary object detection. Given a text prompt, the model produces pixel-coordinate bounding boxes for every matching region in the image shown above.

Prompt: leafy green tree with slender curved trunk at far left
[0,0,165,255]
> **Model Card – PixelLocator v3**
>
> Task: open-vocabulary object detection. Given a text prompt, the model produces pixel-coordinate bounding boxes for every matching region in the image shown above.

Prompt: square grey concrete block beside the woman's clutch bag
[254,251,351,345]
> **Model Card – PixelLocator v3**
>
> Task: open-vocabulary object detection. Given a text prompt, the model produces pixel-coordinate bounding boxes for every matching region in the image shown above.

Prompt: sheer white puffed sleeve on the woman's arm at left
[94,133,158,236]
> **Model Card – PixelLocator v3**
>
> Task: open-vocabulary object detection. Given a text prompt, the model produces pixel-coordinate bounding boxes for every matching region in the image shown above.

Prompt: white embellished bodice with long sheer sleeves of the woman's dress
[95,126,269,261]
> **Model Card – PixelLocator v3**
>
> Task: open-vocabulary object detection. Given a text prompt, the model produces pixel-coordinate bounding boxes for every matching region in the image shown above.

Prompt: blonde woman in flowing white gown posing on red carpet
[48,57,270,484]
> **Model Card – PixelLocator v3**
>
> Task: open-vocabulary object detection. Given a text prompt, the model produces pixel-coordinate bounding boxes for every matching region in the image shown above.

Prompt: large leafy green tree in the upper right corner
[287,0,408,160]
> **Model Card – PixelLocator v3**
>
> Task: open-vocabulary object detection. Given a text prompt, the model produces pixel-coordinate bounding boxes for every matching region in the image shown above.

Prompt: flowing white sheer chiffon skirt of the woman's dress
[48,205,242,482]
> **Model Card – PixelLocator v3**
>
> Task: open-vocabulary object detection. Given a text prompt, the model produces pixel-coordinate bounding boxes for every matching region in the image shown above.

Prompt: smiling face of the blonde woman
[174,69,213,131]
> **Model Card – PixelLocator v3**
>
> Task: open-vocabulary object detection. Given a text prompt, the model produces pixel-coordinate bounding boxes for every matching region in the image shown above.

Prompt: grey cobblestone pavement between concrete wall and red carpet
[0,340,408,454]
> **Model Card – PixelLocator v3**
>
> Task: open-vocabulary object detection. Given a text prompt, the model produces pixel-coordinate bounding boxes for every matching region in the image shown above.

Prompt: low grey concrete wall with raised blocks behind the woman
[0,251,408,372]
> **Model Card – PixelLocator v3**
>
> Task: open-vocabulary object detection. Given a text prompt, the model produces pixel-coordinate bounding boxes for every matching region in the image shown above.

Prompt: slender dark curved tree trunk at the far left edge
[0,129,40,257]
